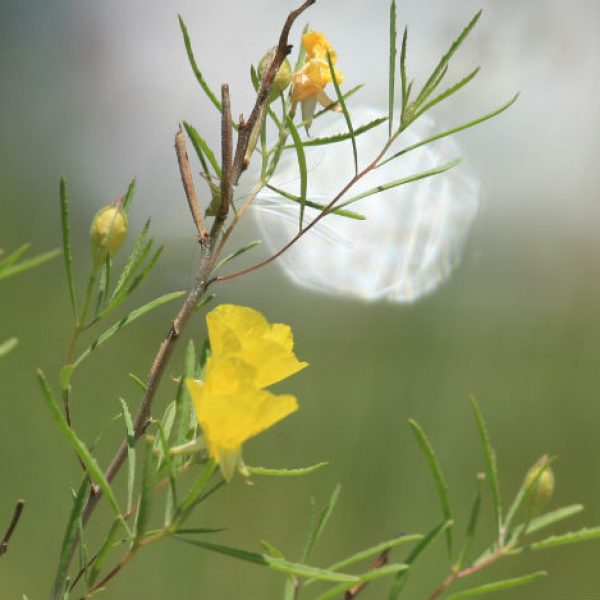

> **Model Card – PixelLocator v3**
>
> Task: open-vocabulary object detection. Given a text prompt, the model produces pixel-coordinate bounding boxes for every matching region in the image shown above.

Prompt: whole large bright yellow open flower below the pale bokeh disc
[186,304,306,481]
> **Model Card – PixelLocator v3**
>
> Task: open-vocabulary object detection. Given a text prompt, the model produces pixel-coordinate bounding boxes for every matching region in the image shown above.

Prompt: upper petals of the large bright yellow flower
[206,304,308,389]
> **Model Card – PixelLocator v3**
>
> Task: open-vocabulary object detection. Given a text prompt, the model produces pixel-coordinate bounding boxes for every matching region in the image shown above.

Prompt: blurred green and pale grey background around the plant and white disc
[0,0,600,600]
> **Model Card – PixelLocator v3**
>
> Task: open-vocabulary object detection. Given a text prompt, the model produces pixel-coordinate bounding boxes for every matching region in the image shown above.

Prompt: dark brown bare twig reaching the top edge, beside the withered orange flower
[233,0,317,185]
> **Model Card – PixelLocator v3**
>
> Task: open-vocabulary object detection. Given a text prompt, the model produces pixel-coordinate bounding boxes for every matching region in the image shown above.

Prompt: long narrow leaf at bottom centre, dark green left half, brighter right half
[175,536,360,583]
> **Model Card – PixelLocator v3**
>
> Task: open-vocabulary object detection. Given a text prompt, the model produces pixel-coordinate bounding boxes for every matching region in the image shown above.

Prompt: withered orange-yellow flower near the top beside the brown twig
[292,31,344,129]
